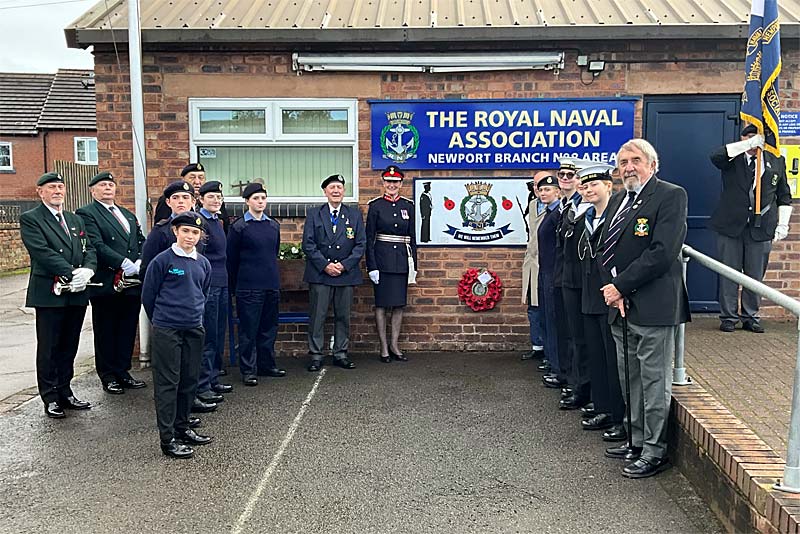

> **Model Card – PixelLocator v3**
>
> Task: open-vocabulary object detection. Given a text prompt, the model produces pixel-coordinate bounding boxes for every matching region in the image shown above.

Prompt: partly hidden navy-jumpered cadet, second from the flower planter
[197,181,233,402]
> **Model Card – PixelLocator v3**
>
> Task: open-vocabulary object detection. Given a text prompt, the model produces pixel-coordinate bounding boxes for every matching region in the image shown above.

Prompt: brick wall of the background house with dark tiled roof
[0,130,95,200]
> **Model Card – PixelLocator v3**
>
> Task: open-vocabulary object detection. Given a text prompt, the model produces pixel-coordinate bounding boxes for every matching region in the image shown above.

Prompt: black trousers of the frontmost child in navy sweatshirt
[150,326,205,444]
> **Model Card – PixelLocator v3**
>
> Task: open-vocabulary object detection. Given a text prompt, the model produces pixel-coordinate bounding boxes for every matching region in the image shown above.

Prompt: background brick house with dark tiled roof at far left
[0,69,97,200]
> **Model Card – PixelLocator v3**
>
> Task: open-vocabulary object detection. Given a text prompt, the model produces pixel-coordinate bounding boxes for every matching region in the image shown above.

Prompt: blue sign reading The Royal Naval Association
[371,99,636,169]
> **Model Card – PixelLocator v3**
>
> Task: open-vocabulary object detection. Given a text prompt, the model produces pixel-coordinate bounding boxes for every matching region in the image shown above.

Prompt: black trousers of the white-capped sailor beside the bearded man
[583,313,625,423]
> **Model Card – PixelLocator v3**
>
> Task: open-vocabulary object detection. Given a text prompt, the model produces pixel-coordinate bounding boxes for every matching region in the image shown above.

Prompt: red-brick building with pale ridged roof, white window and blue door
[66,0,800,360]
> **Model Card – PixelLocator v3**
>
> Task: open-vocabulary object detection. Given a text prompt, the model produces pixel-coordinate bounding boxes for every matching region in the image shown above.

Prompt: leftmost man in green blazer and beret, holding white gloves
[20,172,97,419]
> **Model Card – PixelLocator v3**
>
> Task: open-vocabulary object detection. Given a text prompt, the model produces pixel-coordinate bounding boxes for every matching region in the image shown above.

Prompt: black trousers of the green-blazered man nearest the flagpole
[91,293,142,384]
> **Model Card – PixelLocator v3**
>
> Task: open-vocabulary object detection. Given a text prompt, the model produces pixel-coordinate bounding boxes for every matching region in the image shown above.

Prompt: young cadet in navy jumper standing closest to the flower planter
[228,183,286,386]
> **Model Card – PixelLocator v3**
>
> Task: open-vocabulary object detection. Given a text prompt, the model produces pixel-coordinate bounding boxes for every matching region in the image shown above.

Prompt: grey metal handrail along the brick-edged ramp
[673,245,800,493]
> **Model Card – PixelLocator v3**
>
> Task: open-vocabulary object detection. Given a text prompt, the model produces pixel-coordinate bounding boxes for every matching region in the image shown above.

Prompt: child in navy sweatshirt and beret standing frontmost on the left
[142,212,211,458]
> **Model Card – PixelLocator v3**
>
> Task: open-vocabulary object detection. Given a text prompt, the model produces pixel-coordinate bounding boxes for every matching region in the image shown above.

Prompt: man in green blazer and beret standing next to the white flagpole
[76,172,146,395]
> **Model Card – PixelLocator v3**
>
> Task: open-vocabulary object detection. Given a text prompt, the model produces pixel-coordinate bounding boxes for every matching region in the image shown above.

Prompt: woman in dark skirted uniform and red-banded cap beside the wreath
[367,165,417,363]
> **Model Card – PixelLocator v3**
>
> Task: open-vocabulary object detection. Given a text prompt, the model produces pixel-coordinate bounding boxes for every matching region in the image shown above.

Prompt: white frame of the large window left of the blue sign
[189,98,358,203]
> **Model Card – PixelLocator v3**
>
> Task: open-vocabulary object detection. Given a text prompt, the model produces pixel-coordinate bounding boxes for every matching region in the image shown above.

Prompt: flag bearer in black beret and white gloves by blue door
[709,124,792,333]
